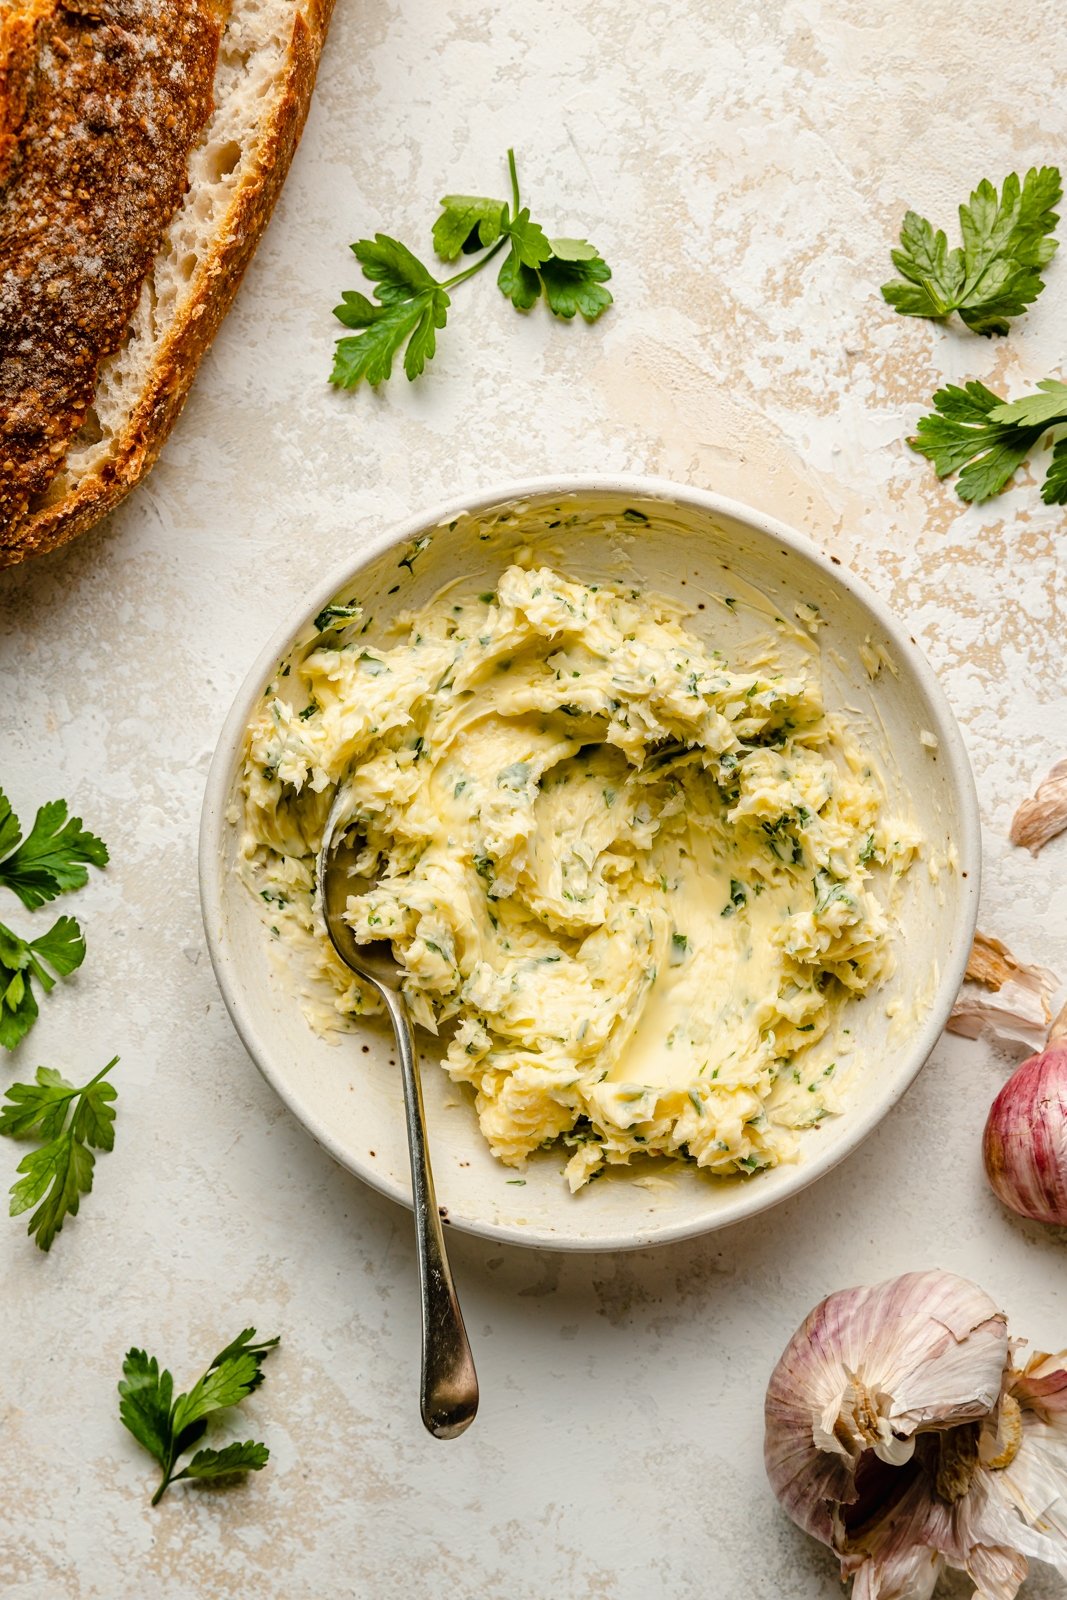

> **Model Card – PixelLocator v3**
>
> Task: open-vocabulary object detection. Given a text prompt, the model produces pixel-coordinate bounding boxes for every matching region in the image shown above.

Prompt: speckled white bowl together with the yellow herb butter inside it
[202,480,977,1248]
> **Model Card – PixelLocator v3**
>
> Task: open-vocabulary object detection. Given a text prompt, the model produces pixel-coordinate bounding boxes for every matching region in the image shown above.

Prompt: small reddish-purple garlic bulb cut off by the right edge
[982,1006,1067,1224]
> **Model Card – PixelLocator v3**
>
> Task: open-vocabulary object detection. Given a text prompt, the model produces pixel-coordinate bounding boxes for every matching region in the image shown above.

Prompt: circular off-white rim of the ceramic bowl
[198,472,981,1251]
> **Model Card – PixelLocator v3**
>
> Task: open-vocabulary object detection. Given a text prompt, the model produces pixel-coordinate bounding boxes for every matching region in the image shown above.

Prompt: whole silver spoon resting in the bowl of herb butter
[315,789,478,1438]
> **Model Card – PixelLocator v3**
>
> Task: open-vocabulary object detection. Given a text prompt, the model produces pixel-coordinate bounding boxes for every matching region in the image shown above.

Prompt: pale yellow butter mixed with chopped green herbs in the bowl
[238,566,918,1189]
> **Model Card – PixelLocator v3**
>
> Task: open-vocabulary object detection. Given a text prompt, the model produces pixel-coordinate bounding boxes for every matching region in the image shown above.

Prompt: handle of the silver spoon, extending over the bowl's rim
[381,987,478,1438]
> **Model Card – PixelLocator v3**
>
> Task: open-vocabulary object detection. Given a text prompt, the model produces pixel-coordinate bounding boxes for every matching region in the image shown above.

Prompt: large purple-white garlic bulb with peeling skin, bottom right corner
[765,1272,1067,1600]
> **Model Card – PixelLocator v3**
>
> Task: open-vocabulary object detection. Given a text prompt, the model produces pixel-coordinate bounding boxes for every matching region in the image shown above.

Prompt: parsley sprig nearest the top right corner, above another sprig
[881,166,1064,336]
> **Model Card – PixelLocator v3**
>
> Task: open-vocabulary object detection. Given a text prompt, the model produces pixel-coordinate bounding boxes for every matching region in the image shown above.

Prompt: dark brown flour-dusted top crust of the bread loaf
[0,0,222,528]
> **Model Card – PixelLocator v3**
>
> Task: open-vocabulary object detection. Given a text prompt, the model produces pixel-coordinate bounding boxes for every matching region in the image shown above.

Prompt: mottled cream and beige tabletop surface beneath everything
[0,0,1067,1600]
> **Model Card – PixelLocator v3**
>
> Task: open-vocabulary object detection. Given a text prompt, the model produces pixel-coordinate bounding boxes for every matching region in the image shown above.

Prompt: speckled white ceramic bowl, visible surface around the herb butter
[200,477,981,1250]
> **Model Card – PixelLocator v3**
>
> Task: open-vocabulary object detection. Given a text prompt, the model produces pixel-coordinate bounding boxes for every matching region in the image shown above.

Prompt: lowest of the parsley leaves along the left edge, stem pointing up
[0,1056,118,1250]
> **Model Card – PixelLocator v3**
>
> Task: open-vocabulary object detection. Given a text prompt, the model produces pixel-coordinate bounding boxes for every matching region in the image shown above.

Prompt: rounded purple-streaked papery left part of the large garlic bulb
[765,1272,1008,1554]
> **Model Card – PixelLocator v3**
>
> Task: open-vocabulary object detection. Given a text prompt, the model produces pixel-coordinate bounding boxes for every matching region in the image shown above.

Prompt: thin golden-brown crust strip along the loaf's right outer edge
[0,0,334,568]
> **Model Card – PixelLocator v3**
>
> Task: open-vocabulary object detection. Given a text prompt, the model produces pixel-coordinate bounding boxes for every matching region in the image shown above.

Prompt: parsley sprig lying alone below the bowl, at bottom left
[118,1328,278,1506]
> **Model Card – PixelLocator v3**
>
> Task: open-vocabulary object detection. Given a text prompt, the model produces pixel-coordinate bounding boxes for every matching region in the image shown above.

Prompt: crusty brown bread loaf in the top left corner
[0,0,333,566]
